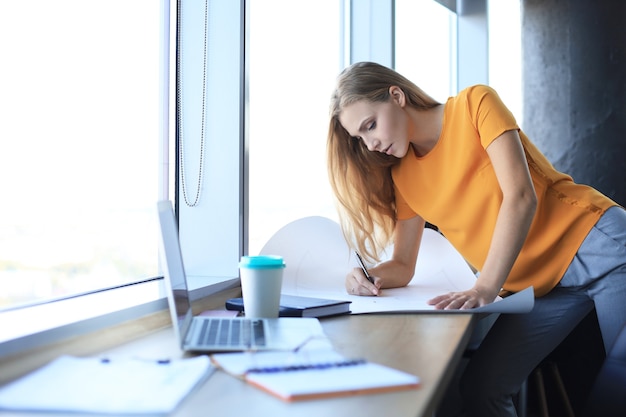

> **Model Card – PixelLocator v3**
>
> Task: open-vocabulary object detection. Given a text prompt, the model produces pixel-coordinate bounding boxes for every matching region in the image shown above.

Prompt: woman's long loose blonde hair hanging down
[327,62,440,261]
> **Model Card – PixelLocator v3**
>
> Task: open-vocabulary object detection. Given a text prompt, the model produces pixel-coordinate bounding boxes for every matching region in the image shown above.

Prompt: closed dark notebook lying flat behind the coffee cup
[226,295,352,317]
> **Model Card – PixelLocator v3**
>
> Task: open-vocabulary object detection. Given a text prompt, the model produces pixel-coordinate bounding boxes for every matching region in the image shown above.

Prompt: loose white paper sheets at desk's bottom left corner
[0,356,215,415]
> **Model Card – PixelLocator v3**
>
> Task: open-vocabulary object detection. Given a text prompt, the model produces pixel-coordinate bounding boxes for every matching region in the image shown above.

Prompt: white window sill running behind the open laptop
[0,277,240,384]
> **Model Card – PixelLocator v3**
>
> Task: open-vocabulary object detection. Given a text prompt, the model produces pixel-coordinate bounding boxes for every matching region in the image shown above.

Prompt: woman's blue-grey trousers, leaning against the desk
[438,207,626,417]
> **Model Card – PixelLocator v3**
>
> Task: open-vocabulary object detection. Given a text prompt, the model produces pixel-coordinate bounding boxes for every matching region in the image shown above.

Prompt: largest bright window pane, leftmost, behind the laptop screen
[0,0,161,309]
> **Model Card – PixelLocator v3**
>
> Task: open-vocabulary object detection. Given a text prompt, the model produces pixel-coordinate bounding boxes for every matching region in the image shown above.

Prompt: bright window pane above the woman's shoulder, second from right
[395,0,456,102]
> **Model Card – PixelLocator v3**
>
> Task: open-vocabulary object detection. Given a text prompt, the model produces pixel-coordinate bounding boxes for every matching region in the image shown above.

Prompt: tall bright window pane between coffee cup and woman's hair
[249,0,341,254]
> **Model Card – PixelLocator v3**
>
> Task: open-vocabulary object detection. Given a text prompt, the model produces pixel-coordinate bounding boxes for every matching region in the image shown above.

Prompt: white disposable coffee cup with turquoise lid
[239,255,285,318]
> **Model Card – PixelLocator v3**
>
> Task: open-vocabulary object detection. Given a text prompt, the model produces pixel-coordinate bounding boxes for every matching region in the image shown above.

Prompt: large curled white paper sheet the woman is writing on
[261,217,534,314]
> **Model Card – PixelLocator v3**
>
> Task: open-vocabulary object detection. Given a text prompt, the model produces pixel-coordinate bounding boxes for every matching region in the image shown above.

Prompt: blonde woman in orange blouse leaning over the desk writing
[328,62,626,417]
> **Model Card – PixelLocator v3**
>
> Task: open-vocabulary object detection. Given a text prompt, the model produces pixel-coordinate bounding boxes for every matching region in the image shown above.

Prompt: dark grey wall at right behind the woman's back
[522,0,626,205]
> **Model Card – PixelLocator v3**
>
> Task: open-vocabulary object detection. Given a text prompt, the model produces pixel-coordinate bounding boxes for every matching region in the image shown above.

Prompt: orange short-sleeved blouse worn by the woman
[392,85,616,296]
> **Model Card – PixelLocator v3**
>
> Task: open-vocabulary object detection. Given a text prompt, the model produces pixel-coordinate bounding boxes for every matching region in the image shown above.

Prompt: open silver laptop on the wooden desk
[157,200,324,352]
